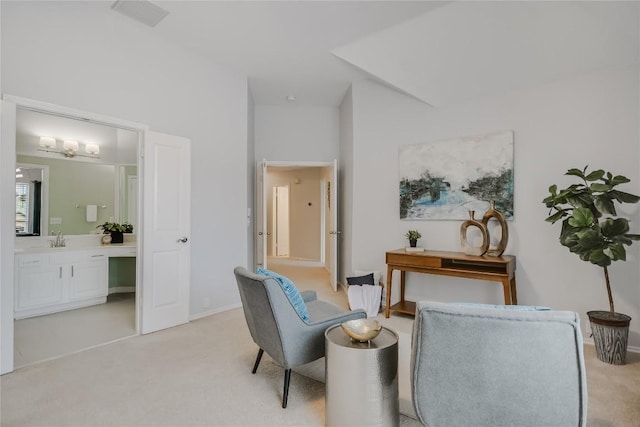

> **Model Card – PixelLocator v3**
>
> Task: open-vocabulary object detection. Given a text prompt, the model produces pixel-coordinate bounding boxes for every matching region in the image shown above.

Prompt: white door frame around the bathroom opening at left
[0,94,149,374]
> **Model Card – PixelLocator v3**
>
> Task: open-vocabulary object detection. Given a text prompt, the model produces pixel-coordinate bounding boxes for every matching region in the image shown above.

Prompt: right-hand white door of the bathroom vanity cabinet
[69,255,109,301]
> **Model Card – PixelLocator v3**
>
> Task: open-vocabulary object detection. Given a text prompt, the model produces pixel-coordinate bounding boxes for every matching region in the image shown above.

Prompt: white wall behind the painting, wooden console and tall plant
[348,66,640,347]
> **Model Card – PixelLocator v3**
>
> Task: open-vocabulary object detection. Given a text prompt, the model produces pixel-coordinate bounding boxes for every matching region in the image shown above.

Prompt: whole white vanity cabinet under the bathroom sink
[14,251,108,319]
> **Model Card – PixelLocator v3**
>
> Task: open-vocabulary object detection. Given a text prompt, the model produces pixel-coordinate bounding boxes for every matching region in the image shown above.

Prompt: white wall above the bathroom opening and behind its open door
[1,2,250,315]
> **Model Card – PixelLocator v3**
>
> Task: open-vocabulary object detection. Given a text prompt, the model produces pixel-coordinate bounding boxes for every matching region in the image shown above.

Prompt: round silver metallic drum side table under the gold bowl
[324,325,400,426]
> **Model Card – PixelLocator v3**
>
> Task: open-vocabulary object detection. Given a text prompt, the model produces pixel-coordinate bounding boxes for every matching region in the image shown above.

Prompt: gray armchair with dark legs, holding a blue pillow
[233,267,366,408]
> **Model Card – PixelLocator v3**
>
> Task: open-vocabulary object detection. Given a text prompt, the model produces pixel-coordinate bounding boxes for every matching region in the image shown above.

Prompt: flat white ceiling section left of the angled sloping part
[110,0,446,106]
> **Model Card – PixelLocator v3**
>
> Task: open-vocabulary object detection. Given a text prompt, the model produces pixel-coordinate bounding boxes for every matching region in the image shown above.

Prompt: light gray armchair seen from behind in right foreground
[411,301,587,427]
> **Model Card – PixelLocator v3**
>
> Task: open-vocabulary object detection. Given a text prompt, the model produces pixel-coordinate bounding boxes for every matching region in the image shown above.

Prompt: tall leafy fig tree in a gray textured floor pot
[542,167,640,365]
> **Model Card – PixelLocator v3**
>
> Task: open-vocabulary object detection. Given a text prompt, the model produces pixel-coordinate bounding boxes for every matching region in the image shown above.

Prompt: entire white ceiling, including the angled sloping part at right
[105,0,640,107]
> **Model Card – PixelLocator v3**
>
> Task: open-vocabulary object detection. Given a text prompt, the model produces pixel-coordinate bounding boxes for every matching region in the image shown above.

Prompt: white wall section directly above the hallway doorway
[255,105,340,162]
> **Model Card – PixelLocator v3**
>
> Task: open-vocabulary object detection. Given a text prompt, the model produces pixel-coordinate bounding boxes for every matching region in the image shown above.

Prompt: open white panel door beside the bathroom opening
[141,132,191,334]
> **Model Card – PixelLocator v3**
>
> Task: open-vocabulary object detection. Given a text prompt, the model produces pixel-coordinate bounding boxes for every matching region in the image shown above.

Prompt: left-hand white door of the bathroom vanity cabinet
[16,265,65,310]
